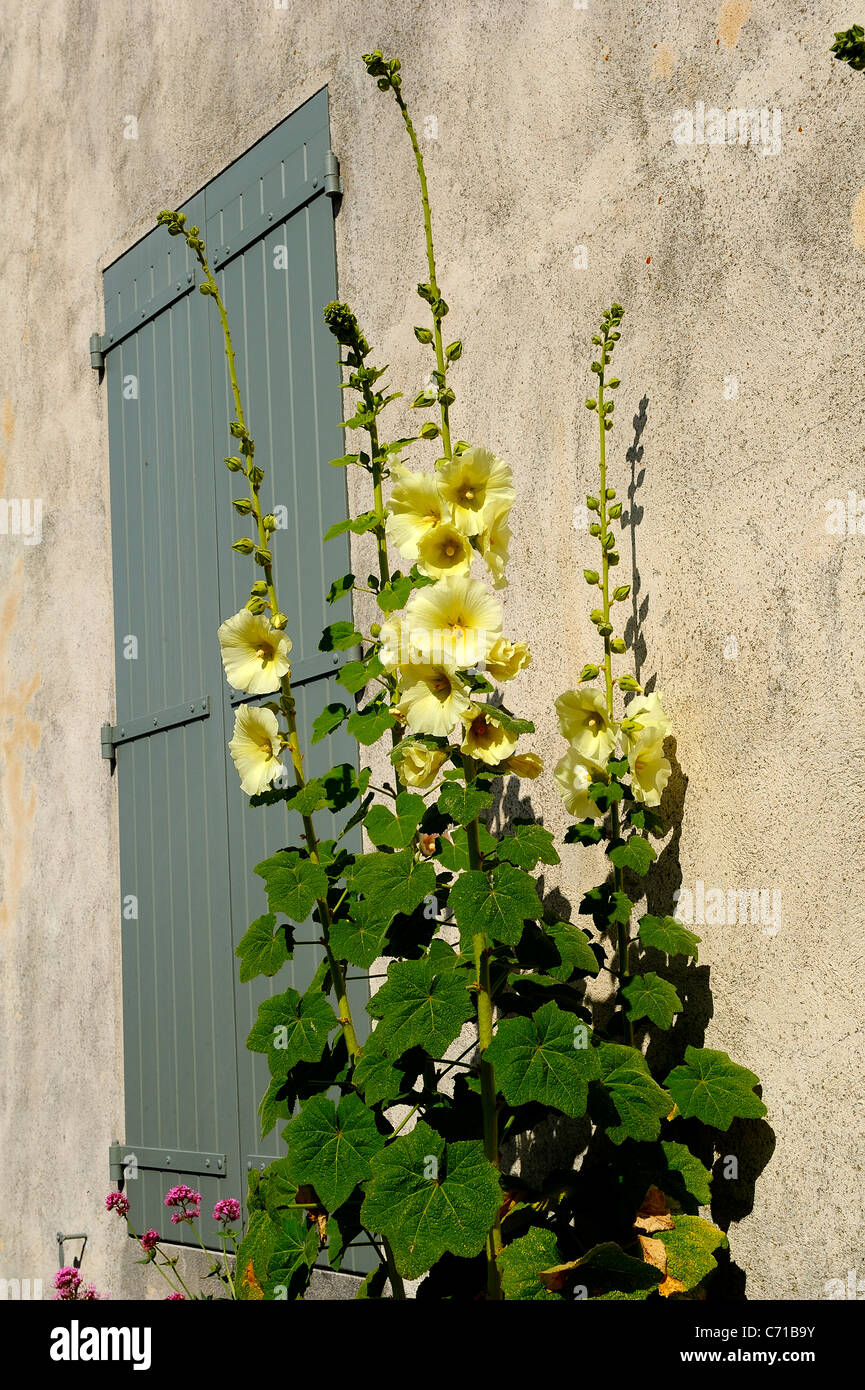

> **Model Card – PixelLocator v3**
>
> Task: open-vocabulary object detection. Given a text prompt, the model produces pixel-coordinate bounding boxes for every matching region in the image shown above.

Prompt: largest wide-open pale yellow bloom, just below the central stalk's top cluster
[405,575,502,669]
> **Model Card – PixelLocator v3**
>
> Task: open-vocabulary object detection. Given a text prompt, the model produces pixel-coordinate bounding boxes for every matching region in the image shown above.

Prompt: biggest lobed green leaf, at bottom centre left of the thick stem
[362,1120,502,1279]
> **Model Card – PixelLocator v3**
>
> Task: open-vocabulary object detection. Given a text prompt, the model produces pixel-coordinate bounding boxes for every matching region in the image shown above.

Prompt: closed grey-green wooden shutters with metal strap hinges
[102,90,369,1268]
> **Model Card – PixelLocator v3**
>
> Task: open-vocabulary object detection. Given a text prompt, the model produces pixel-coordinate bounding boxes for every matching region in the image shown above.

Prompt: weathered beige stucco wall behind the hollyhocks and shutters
[0,0,865,1300]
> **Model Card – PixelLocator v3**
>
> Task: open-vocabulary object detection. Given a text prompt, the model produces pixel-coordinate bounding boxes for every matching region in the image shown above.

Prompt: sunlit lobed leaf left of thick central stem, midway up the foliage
[367,956,474,1058]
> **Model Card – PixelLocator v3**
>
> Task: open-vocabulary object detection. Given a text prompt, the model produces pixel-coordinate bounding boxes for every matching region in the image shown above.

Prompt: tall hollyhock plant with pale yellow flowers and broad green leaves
[115,51,765,1304]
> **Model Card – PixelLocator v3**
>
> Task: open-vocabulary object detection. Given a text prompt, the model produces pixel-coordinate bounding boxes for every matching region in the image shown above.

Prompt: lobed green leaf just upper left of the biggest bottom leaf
[282,1091,384,1211]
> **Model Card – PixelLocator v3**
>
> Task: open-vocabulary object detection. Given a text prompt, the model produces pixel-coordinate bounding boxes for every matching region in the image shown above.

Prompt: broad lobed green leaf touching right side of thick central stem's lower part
[484,1001,601,1116]
